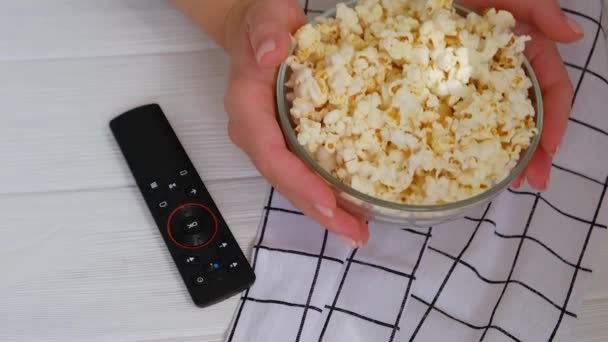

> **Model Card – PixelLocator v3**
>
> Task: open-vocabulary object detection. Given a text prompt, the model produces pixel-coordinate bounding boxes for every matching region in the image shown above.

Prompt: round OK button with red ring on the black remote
[167,203,218,249]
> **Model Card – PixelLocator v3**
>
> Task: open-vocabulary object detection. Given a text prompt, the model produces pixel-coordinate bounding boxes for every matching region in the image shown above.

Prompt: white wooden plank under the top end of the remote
[0,50,259,193]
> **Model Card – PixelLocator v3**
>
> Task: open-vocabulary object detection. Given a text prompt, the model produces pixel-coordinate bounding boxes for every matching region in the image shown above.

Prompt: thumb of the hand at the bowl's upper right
[461,0,583,42]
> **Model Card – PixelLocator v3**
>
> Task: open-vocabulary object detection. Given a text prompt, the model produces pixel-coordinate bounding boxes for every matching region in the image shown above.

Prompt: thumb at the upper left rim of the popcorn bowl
[245,0,306,68]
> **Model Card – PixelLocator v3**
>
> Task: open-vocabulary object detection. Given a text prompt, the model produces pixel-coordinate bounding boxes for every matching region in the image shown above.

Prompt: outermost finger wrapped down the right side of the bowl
[518,23,574,156]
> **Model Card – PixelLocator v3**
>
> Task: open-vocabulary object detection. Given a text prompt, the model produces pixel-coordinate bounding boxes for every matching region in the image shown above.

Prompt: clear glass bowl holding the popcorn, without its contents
[276,1,543,227]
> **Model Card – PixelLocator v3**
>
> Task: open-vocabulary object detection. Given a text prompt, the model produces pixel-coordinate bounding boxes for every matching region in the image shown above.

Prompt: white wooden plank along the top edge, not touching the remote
[0,0,215,61]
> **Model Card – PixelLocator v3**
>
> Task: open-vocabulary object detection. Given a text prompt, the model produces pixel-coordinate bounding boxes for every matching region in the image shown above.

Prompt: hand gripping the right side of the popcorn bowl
[461,0,583,191]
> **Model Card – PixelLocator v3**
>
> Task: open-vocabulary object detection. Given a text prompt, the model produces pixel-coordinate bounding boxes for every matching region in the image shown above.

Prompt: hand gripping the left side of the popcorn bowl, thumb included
[224,0,369,247]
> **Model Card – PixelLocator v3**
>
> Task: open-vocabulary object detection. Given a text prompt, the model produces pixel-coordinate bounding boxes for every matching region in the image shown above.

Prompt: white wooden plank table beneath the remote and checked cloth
[0,0,608,342]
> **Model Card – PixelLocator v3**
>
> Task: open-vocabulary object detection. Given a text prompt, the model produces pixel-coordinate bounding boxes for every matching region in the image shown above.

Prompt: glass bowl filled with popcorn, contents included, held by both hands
[277,0,543,226]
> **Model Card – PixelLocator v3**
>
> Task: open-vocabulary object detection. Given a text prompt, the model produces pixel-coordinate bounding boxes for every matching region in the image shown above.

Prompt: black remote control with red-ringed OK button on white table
[110,104,255,307]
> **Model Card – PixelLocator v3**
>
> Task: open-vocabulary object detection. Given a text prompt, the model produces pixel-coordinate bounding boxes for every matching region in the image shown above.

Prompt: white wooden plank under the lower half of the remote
[0,178,268,341]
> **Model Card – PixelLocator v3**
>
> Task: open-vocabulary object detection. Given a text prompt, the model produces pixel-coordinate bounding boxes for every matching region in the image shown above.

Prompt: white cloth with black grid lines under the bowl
[227,0,608,342]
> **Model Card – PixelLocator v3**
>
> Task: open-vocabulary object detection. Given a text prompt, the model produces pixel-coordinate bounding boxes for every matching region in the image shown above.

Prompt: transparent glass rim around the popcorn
[276,0,544,212]
